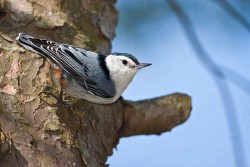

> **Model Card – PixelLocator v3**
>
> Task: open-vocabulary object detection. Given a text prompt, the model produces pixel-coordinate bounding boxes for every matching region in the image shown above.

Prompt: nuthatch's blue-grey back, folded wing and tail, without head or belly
[16,33,116,98]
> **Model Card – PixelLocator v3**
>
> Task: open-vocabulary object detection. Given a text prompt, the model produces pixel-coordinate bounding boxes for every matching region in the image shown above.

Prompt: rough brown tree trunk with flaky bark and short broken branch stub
[0,0,191,167]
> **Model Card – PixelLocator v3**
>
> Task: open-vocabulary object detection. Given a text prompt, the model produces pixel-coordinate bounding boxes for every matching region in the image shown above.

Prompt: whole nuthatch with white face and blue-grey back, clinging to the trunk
[16,33,151,104]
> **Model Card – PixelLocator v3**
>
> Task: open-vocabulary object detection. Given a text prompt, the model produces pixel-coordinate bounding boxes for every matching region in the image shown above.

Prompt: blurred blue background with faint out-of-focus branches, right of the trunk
[107,0,250,167]
